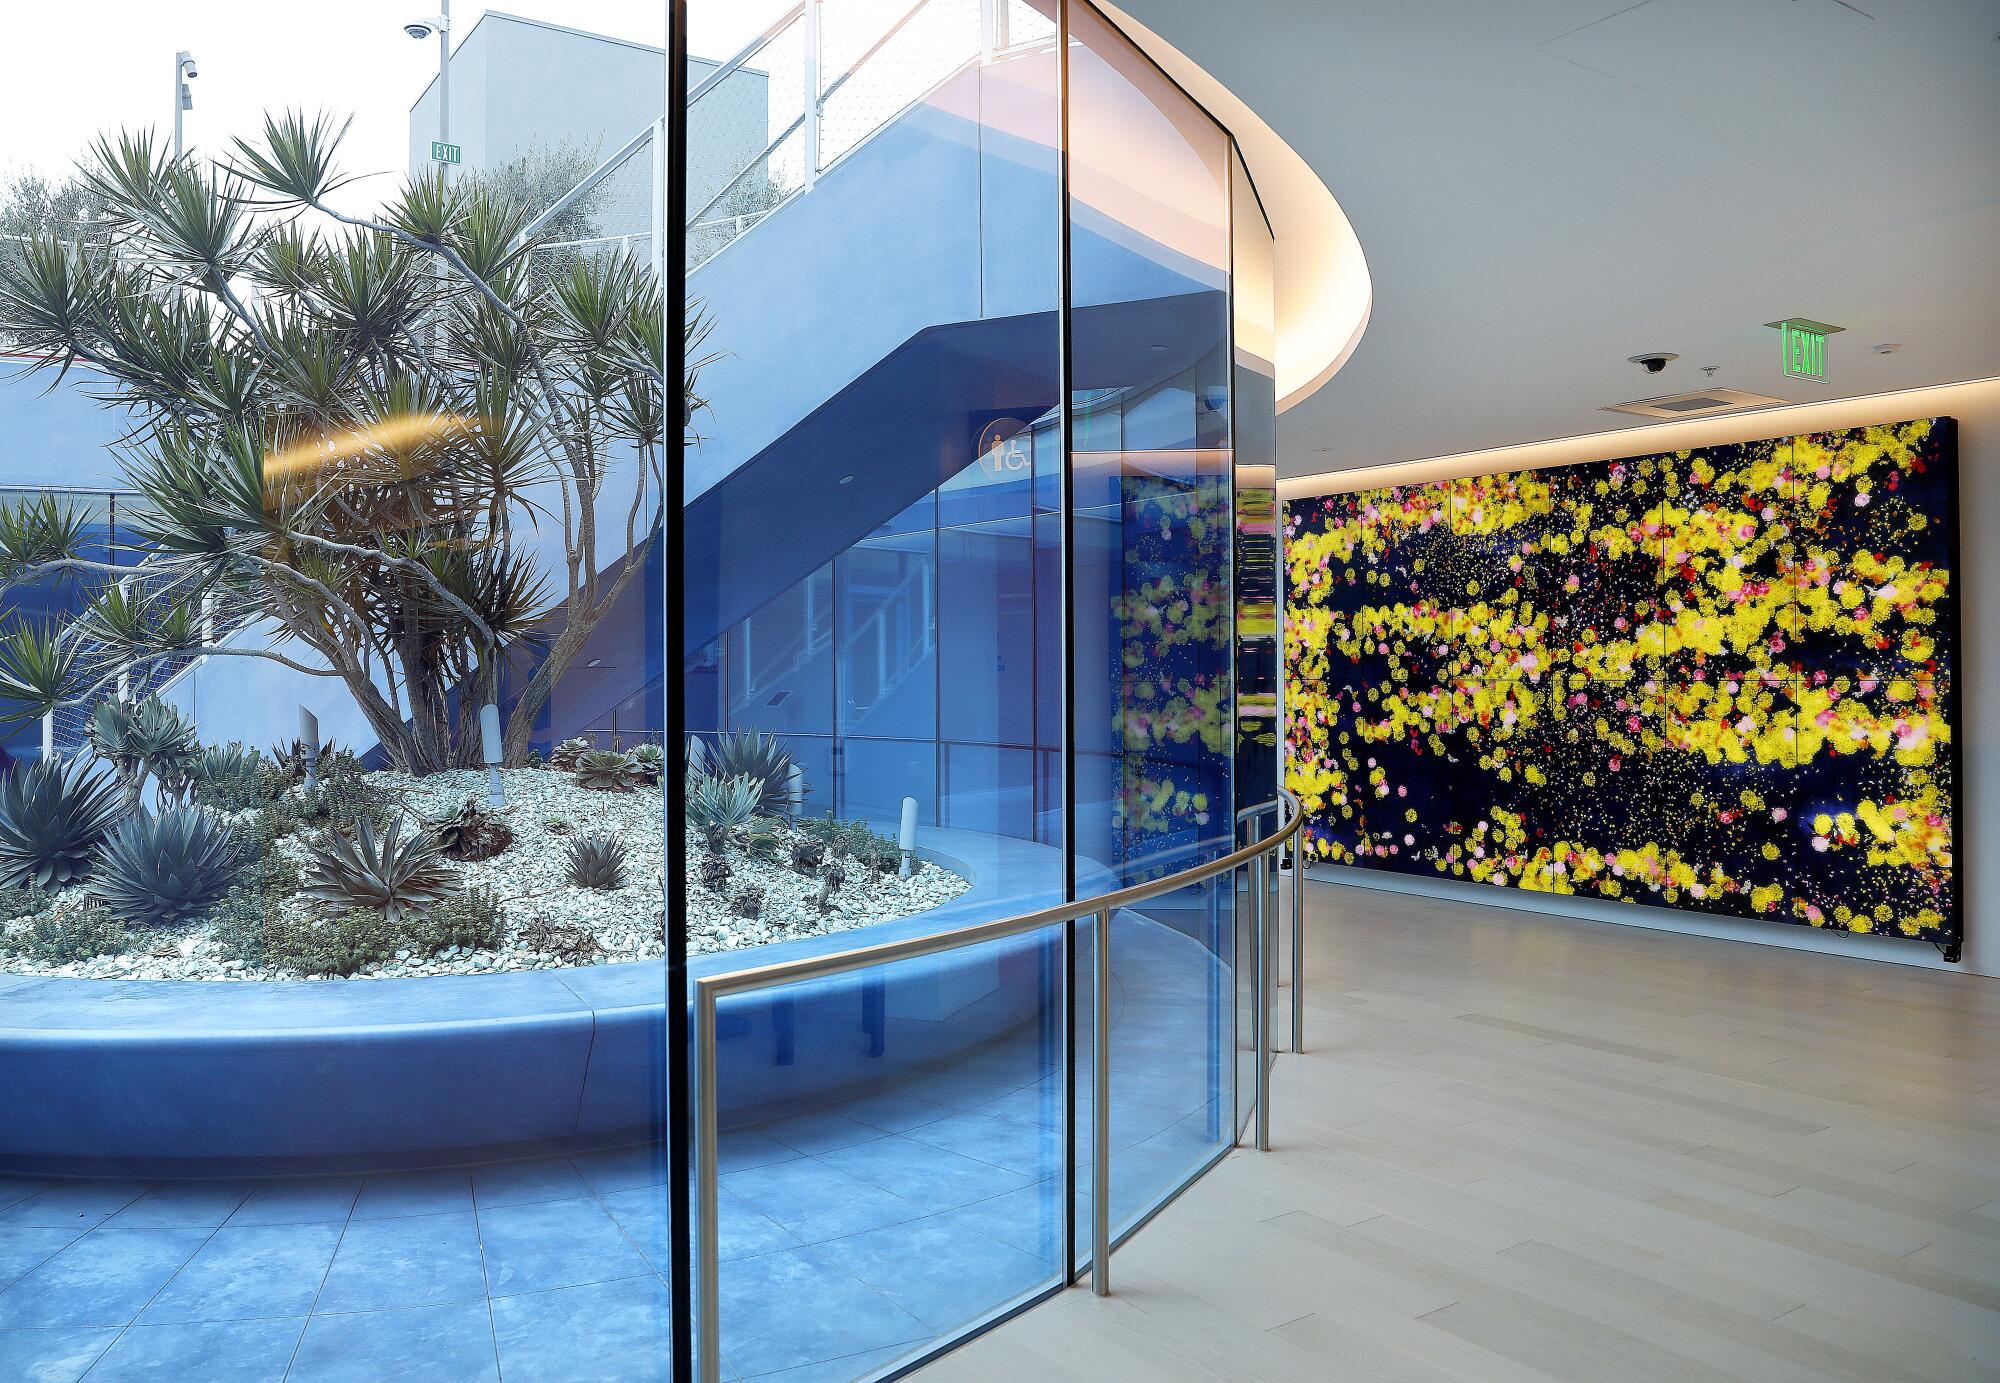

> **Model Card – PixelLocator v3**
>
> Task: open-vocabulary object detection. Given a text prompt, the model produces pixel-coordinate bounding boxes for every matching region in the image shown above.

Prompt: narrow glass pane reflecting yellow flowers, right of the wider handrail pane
[1068,4,1234,1231]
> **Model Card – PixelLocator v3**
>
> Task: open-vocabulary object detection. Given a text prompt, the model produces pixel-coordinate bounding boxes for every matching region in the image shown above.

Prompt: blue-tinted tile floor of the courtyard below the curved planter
[0,923,1228,1383]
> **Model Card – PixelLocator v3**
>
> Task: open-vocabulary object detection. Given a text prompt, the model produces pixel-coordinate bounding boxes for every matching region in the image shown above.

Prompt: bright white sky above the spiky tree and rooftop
[0,0,790,213]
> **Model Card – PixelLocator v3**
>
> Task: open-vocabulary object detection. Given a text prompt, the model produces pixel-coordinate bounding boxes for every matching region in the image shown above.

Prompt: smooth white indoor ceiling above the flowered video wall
[1120,0,2000,476]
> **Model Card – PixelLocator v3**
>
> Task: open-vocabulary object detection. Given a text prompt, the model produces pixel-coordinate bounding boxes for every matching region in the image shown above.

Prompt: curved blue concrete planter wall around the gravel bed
[0,829,1104,1175]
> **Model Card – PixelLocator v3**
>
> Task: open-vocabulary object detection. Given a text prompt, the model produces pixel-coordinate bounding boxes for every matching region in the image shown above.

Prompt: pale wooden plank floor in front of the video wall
[920,883,2000,1383]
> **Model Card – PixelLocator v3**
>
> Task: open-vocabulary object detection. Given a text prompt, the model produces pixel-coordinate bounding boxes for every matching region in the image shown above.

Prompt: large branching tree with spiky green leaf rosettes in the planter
[0,114,702,773]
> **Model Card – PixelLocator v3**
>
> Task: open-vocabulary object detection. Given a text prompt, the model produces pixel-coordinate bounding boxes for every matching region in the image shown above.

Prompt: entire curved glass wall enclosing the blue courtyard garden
[0,0,1270,1379]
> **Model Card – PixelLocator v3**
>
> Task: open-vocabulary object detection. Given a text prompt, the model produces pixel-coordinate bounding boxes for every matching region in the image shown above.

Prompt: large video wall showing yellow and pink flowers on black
[1284,418,1962,955]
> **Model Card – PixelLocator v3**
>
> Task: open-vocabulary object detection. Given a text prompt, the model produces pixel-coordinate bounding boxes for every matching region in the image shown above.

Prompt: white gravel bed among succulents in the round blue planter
[0,767,970,979]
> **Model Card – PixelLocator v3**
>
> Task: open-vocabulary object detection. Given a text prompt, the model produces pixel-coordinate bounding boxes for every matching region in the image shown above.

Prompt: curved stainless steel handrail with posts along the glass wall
[694,791,1304,1383]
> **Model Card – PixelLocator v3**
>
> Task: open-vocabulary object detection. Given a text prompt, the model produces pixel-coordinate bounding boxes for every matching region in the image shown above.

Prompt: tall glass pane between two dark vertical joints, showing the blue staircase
[678,0,1066,1377]
